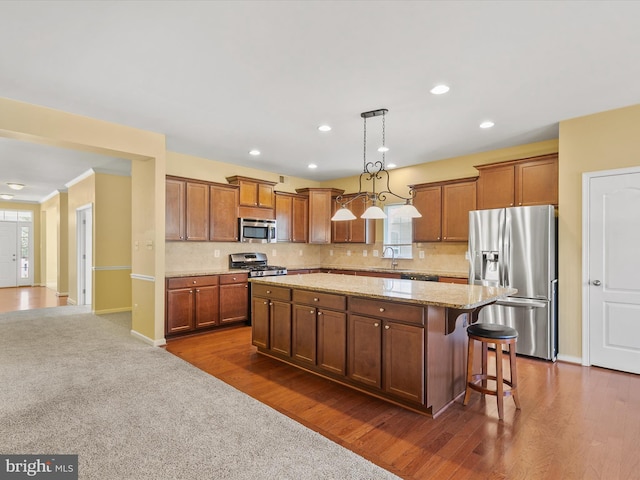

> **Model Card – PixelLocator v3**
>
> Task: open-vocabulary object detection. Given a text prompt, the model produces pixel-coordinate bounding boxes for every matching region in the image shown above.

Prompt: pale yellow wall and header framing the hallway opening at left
[0,98,166,344]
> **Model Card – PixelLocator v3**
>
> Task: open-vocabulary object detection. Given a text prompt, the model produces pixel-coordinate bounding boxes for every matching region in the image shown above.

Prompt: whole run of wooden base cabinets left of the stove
[165,273,249,336]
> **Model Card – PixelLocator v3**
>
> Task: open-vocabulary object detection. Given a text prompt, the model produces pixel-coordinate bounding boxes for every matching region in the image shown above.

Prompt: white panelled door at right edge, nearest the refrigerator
[585,172,640,373]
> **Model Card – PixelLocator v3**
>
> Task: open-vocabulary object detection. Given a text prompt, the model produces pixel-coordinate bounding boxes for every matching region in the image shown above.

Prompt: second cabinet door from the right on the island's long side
[347,315,382,388]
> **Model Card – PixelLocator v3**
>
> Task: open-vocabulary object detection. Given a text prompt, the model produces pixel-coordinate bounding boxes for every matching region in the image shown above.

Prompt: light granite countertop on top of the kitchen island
[249,273,517,310]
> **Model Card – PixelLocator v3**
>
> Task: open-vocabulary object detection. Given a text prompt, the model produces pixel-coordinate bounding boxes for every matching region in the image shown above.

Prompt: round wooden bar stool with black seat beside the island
[462,323,520,420]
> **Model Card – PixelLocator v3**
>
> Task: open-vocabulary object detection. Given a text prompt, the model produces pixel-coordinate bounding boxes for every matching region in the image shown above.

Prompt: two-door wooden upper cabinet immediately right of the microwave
[275,192,309,243]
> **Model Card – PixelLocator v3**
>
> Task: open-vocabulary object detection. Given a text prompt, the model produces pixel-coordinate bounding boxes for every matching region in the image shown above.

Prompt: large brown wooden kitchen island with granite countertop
[250,273,516,416]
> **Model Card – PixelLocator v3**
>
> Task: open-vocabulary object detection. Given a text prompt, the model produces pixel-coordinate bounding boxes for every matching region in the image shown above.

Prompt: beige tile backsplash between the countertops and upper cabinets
[165,242,469,275]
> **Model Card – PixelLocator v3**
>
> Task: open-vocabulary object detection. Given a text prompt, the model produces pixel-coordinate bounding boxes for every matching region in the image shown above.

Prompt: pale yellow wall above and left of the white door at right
[558,105,640,357]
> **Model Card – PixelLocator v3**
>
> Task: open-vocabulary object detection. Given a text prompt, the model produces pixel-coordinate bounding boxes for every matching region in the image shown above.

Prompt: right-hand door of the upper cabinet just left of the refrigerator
[442,182,476,242]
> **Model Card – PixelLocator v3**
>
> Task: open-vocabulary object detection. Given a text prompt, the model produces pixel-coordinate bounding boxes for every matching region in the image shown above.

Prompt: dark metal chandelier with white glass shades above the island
[331,108,422,222]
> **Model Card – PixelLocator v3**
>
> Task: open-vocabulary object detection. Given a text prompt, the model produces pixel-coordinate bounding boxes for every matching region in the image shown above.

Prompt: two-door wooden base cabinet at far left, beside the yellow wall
[165,275,220,335]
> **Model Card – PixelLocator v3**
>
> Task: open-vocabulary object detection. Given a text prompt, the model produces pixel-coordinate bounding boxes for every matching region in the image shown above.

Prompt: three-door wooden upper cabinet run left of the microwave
[165,176,238,242]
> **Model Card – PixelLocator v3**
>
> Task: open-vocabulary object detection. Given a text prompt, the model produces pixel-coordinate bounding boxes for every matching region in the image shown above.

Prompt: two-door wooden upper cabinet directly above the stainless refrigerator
[476,153,558,209]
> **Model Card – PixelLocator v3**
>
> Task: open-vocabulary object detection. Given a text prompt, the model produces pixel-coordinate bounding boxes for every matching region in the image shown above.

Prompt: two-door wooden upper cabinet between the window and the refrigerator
[412,177,477,242]
